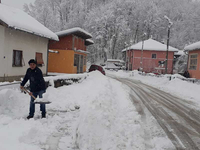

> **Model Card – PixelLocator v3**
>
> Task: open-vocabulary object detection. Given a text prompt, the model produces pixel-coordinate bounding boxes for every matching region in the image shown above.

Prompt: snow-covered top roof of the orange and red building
[56,27,92,39]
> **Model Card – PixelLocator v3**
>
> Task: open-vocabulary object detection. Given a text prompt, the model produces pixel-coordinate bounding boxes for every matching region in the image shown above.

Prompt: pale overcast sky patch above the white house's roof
[1,0,35,9]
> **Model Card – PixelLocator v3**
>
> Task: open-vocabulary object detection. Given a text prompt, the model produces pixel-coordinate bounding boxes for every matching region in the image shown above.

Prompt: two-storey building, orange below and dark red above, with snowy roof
[48,27,94,73]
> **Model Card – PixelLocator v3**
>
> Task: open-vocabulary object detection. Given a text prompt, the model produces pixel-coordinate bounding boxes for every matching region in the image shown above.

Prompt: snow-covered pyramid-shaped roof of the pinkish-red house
[122,39,178,52]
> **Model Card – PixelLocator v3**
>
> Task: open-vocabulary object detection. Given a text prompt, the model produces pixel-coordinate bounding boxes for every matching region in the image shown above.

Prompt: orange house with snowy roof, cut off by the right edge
[184,42,200,79]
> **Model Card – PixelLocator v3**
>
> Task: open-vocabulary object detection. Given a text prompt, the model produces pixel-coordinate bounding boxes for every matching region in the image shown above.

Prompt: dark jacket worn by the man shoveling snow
[21,67,46,92]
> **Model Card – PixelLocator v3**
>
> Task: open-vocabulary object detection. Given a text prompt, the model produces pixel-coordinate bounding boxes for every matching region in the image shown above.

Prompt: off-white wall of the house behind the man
[0,28,48,81]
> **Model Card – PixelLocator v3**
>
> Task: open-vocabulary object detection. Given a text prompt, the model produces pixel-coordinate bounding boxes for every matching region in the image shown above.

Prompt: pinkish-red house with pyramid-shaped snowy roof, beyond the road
[122,39,178,74]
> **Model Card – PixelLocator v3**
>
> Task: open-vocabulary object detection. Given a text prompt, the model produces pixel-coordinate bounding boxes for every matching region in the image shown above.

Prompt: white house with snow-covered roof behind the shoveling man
[0,3,58,81]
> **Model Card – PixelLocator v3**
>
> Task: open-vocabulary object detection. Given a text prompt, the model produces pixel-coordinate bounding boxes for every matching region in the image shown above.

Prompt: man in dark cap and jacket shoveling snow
[20,59,46,119]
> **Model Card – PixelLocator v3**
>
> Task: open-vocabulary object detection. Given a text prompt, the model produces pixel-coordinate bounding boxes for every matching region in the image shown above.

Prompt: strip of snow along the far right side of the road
[106,70,200,107]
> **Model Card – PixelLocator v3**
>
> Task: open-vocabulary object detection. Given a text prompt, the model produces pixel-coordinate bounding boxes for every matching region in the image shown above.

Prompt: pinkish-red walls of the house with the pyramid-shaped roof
[131,50,174,74]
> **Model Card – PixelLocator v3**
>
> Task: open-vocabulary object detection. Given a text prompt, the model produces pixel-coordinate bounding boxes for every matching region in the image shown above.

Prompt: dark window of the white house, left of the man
[12,50,22,67]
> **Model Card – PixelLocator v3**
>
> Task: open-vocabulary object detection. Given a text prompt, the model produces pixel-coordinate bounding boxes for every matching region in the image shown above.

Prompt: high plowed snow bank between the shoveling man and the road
[73,72,144,150]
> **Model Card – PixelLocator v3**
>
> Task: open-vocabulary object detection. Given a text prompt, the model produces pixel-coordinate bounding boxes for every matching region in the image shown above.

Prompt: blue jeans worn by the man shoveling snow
[29,90,46,116]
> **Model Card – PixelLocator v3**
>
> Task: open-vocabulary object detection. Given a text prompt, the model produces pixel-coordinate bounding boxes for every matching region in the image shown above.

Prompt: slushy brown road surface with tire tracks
[114,79,200,150]
